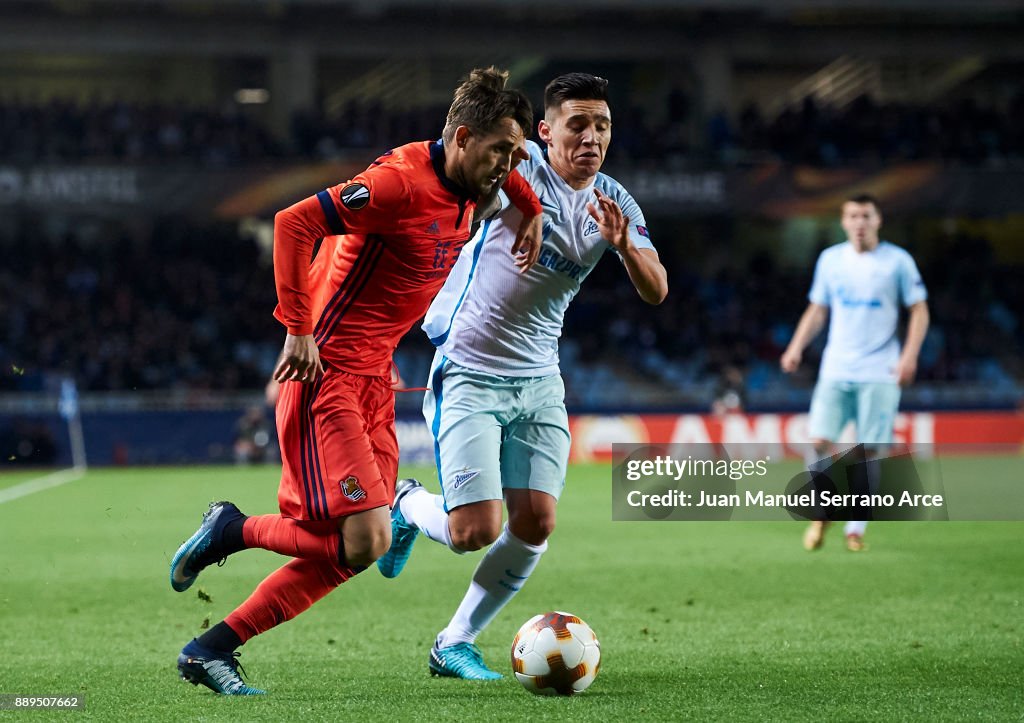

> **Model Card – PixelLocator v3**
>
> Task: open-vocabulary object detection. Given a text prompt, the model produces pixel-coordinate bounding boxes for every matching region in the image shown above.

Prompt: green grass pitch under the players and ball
[0,466,1024,722]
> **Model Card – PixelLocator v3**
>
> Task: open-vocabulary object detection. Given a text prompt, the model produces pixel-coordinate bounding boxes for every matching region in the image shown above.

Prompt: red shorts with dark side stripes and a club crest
[278,369,398,520]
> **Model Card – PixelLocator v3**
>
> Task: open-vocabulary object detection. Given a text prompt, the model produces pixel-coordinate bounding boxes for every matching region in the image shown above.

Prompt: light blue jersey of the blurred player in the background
[808,241,928,382]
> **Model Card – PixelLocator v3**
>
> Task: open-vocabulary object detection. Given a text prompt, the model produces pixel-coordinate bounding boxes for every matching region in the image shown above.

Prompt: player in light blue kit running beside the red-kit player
[378,73,668,680]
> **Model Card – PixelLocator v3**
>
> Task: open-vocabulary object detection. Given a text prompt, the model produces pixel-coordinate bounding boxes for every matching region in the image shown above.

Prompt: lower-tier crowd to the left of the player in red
[0,221,282,391]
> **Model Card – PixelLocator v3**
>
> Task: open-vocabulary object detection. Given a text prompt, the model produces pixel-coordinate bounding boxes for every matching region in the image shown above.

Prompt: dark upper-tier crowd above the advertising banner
[0,91,1024,167]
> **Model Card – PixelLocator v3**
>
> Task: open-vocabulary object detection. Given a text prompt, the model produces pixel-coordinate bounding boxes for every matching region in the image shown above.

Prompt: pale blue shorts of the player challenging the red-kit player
[423,351,570,510]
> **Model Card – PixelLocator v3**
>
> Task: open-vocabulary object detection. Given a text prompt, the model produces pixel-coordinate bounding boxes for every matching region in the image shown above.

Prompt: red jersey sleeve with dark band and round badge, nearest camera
[273,166,413,336]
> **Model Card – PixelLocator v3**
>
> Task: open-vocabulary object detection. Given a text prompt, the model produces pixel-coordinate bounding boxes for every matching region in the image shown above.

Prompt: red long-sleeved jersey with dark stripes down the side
[273,141,541,376]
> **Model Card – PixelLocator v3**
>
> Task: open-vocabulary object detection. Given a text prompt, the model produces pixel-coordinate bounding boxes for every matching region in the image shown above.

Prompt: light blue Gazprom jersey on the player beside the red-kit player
[423,141,654,377]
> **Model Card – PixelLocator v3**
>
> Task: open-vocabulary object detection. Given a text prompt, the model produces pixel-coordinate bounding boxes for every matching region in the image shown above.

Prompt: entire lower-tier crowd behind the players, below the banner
[0,219,1024,407]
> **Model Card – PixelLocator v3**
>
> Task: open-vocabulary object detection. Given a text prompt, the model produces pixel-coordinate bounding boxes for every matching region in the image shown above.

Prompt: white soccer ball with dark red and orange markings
[512,611,601,695]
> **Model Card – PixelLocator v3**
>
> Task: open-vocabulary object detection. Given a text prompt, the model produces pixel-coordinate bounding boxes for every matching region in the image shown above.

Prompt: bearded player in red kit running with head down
[171,68,541,695]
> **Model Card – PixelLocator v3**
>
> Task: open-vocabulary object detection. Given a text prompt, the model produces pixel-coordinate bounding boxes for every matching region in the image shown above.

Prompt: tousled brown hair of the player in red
[442,66,534,143]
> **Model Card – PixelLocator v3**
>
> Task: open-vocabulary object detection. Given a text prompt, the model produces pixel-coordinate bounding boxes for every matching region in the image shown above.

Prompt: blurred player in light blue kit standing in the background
[780,195,929,552]
